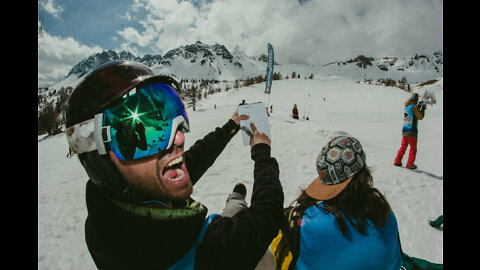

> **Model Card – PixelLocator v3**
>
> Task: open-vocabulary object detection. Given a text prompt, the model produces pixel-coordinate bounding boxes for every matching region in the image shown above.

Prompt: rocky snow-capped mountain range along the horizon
[51,41,443,89]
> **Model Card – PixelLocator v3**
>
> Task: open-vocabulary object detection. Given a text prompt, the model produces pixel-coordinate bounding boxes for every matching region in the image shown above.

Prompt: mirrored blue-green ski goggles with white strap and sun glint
[67,83,190,160]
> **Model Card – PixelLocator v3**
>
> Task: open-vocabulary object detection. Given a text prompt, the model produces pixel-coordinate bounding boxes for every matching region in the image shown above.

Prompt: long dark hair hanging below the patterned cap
[295,165,391,236]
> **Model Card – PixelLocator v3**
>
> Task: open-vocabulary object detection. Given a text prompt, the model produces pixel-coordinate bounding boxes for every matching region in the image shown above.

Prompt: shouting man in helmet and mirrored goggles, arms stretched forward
[66,61,283,269]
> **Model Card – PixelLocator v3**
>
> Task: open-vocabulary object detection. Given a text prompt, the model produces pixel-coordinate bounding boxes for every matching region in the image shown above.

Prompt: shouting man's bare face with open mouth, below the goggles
[109,131,193,202]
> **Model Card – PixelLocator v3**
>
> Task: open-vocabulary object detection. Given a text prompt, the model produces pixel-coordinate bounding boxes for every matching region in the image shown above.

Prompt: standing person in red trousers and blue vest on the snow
[393,93,426,170]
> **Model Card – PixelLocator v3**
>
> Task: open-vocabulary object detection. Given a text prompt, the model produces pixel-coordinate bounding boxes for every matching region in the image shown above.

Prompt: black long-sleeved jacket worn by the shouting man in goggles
[85,120,284,270]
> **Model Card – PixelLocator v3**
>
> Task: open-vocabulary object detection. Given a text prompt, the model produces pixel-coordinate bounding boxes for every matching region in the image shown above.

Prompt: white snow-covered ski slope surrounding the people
[38,75,443,270]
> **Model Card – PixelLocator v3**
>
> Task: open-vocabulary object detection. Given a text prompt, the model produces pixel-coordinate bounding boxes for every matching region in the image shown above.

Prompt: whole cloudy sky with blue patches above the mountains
[38,0,443,86]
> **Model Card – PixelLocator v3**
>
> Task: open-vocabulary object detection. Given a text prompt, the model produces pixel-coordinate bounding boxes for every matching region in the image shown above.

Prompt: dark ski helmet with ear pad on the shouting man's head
[65,61,180,202]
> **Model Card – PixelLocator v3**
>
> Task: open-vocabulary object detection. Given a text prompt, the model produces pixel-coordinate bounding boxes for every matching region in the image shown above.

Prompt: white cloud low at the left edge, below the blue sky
[38,28,102,86]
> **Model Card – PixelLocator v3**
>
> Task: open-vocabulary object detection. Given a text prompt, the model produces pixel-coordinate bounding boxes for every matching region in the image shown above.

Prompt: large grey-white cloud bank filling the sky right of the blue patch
[123,0,443,64]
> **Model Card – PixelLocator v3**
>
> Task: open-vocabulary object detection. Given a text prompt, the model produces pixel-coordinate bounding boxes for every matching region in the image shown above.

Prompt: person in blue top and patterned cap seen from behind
[271,136,403,270]
